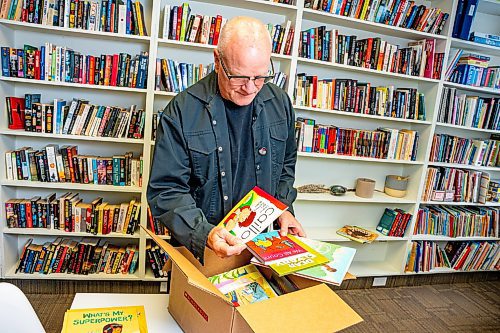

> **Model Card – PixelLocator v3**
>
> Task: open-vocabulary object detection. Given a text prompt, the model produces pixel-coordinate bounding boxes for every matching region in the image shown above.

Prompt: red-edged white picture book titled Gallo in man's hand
[219,186,288,243]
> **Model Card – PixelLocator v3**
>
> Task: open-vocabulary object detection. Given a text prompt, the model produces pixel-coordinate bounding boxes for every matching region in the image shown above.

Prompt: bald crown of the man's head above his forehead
[217,16,272,54]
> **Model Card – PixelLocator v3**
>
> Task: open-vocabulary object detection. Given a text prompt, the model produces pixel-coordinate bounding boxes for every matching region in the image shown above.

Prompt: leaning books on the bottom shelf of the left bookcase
[16,237,139,275]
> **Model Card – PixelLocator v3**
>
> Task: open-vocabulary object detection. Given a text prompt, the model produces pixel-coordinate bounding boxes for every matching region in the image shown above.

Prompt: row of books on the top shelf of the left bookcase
[0,0,148,36]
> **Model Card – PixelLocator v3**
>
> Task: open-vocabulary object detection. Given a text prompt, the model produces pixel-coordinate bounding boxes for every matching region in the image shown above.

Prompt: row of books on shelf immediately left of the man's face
[155,59,214,93]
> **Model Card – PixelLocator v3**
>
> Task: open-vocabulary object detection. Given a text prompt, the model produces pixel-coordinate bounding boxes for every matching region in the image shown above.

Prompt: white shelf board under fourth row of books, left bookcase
[2,180,142,193]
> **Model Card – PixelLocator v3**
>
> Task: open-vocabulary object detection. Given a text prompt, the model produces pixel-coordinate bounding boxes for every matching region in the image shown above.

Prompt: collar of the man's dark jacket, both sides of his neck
[187,71,275,104]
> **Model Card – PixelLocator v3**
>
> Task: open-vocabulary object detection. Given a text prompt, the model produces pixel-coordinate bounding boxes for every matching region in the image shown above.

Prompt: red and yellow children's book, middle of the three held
[247,231,329,276]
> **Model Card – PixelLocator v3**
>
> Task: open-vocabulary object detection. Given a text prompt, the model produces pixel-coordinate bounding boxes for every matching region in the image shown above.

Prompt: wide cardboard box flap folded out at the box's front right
[236,284,363,333]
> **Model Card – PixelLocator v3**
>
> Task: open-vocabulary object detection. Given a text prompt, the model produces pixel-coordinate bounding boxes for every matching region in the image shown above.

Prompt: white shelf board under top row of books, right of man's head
[303,8,446,40]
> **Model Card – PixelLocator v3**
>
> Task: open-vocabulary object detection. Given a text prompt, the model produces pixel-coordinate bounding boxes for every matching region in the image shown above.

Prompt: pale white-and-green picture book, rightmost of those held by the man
[295,237,356,286]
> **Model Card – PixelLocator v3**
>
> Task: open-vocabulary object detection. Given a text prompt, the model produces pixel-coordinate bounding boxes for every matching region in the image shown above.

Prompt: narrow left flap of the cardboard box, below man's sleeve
[141,225,227,301]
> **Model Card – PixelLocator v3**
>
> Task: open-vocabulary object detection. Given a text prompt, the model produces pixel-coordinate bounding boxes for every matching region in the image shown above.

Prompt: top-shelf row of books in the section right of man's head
[304,0,449,35]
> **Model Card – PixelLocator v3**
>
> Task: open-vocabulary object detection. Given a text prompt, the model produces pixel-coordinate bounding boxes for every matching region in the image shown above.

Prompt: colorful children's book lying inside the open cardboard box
[208,264,276,306]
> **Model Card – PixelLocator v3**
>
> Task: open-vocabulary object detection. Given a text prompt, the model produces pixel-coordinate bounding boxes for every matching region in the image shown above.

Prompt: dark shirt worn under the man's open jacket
[224,99,257,206]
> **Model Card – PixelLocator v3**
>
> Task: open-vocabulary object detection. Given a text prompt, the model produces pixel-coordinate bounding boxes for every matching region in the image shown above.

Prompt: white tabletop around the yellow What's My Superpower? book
[71,293,182,333]
